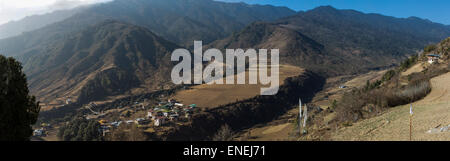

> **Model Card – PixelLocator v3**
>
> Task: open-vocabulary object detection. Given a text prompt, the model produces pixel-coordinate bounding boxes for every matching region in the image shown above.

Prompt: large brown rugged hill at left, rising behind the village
[23,20,180,101]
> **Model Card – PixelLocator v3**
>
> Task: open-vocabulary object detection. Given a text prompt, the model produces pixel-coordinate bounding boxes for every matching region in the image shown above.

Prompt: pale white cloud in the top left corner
[0,0,112,24]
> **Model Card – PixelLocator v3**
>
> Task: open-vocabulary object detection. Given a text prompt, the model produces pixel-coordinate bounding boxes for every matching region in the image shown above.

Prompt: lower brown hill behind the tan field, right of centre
[209,22,348,76]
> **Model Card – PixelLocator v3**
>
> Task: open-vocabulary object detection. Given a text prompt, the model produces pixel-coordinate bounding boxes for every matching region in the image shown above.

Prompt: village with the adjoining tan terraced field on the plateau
[34,65,309,140]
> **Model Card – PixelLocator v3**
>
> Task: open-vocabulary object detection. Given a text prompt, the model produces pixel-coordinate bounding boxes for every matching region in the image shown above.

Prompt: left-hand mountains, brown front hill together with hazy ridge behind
[0,0,295,101]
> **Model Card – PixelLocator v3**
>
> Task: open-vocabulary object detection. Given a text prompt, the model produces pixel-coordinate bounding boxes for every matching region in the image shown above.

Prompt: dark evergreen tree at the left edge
[0,55,40,141]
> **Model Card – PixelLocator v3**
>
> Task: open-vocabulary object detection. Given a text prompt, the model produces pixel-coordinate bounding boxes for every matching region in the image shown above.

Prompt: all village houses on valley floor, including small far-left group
[33,99,199,137]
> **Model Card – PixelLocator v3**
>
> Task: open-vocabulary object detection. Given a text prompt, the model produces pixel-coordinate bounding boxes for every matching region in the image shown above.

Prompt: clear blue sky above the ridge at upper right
[220,0,450,25]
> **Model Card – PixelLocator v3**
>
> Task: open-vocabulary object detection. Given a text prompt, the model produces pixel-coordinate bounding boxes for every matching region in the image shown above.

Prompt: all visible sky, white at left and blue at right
[0,0,450,25]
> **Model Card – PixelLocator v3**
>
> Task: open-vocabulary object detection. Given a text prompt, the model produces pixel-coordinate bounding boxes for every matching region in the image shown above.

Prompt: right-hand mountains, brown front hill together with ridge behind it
[212,6,450,76]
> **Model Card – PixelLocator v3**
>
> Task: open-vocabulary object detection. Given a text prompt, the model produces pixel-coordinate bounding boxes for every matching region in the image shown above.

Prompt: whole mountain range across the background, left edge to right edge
[0,0,450,102]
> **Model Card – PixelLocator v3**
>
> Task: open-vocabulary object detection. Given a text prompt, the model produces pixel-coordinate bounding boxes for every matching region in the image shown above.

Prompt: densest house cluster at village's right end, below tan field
[147,99,197,126]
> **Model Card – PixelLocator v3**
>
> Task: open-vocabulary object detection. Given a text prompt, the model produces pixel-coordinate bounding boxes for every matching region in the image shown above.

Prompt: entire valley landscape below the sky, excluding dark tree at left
[0,0,450,141]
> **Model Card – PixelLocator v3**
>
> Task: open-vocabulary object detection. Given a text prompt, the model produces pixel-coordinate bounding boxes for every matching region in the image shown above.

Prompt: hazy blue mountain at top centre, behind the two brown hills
[67,0,295,46]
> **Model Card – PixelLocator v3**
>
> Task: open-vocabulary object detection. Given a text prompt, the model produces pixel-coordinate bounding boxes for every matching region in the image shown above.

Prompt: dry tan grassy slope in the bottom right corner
[332,73,450,140]
